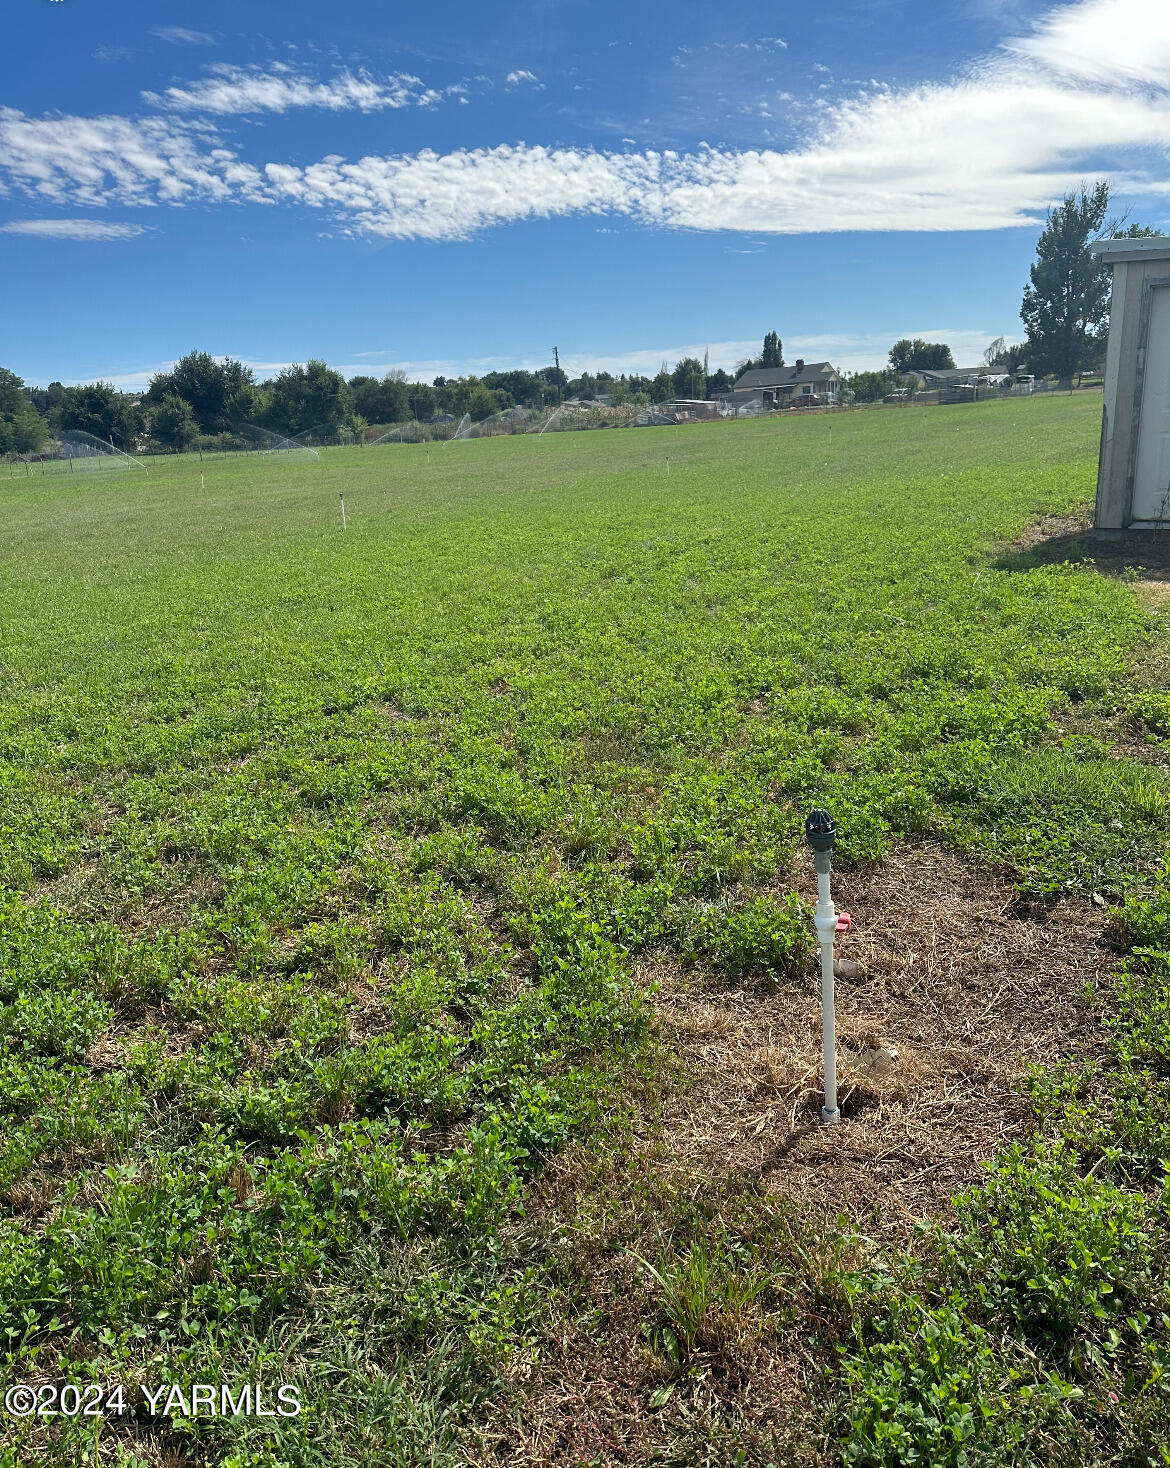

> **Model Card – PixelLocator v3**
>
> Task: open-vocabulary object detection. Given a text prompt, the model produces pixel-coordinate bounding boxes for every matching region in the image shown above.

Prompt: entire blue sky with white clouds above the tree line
[0,0,1170,388]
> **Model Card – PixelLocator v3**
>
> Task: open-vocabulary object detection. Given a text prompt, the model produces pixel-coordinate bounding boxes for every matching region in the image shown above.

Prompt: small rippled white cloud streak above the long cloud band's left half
[142,62,442,115]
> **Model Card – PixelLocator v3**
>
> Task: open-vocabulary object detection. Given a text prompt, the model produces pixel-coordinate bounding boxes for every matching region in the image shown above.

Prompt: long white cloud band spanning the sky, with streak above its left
[0,0,1170,239]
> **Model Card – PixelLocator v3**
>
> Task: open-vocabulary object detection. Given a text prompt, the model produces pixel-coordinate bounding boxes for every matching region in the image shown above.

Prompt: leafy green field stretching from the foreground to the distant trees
[0,395,1170,1468]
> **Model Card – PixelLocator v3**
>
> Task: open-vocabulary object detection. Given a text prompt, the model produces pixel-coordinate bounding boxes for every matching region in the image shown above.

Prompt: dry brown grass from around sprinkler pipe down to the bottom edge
[467,846,1116,1468]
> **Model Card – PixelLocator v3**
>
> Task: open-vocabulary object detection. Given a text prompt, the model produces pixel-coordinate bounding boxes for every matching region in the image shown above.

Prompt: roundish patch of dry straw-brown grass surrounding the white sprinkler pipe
[647,846,1114,1242]
